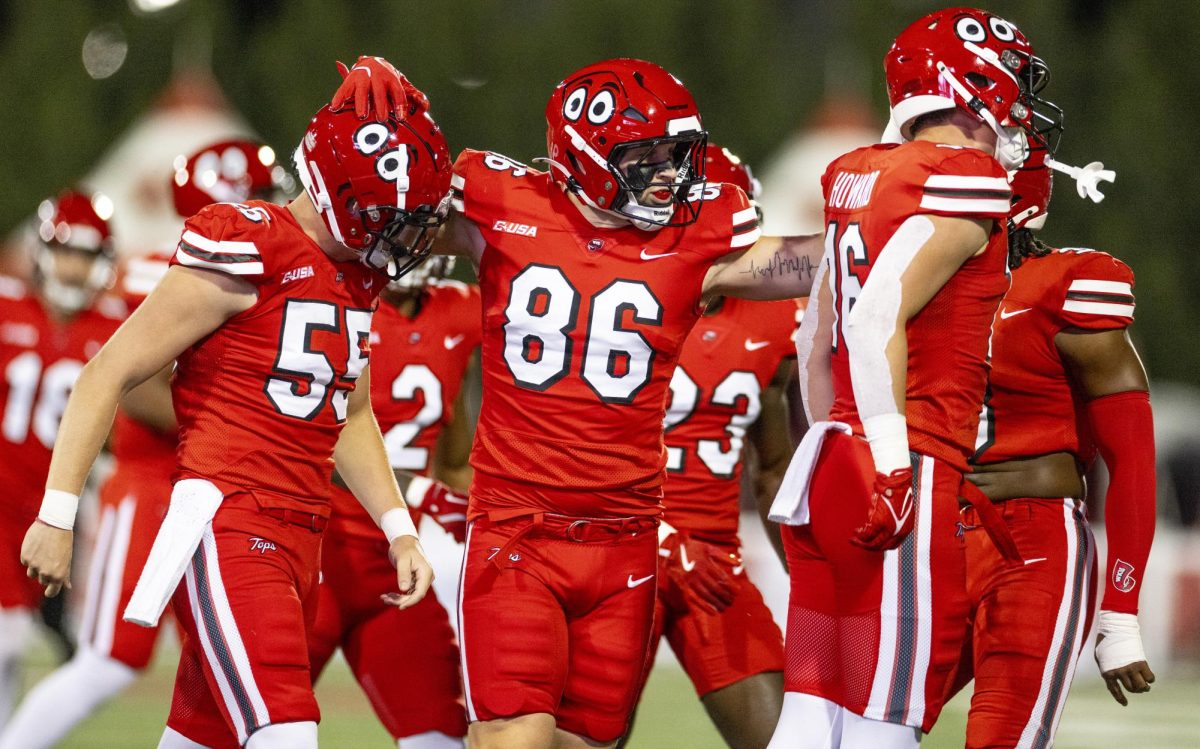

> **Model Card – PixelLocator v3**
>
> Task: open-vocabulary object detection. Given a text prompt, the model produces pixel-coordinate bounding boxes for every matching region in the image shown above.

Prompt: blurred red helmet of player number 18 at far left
[34,190,115,314]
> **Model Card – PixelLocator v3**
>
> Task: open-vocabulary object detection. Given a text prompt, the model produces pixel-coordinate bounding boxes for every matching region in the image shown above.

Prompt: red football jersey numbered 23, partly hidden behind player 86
[662,298,797,543]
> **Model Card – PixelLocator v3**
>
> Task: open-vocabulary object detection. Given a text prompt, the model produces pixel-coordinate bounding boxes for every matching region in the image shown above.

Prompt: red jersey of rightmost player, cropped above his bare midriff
[974,250,1134,465]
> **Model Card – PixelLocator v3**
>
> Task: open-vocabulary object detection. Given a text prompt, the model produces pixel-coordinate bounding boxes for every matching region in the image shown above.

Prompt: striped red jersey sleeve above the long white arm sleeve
[913,146,1012,221]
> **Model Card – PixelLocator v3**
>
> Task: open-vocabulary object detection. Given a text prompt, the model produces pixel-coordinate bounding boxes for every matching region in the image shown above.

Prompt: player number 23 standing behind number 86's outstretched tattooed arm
[624,143,796,749]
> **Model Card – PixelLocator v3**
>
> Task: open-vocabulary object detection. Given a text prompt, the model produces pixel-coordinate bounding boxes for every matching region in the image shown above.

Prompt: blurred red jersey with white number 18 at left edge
[0,276,125,513]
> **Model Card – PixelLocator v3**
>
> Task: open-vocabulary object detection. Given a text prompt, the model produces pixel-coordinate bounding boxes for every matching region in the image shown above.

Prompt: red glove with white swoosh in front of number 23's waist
[659,532,742,613]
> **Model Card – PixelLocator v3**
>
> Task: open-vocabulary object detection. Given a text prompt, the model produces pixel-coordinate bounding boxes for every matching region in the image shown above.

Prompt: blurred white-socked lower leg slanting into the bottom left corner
[0,648,137,749]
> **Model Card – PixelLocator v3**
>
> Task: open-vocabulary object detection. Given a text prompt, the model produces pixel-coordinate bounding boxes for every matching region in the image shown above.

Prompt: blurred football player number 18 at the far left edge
[0,190,125,726]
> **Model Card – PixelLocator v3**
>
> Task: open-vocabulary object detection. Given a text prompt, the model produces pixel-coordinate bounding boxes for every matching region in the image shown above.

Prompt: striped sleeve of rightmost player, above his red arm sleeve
[1055,250,1134,330]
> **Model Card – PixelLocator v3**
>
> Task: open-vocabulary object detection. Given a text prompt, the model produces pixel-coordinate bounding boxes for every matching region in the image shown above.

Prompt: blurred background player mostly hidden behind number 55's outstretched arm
[0,140,280,749]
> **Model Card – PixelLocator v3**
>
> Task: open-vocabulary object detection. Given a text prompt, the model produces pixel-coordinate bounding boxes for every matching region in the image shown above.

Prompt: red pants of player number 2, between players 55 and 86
[308,533,467,738]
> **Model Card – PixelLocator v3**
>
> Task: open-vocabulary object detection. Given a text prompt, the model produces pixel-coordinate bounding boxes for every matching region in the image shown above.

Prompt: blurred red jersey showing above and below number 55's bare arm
[109,252,179,472]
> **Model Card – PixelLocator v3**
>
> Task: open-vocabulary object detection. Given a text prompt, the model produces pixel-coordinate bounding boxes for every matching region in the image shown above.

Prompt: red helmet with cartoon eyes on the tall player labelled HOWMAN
[883,7,1062,169]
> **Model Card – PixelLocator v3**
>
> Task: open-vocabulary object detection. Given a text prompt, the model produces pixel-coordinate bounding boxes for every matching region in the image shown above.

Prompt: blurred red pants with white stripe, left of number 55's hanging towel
[79,463,170,670]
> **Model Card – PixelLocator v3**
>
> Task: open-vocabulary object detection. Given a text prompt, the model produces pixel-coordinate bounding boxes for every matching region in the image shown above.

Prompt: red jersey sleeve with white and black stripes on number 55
[170,203,271,287]
